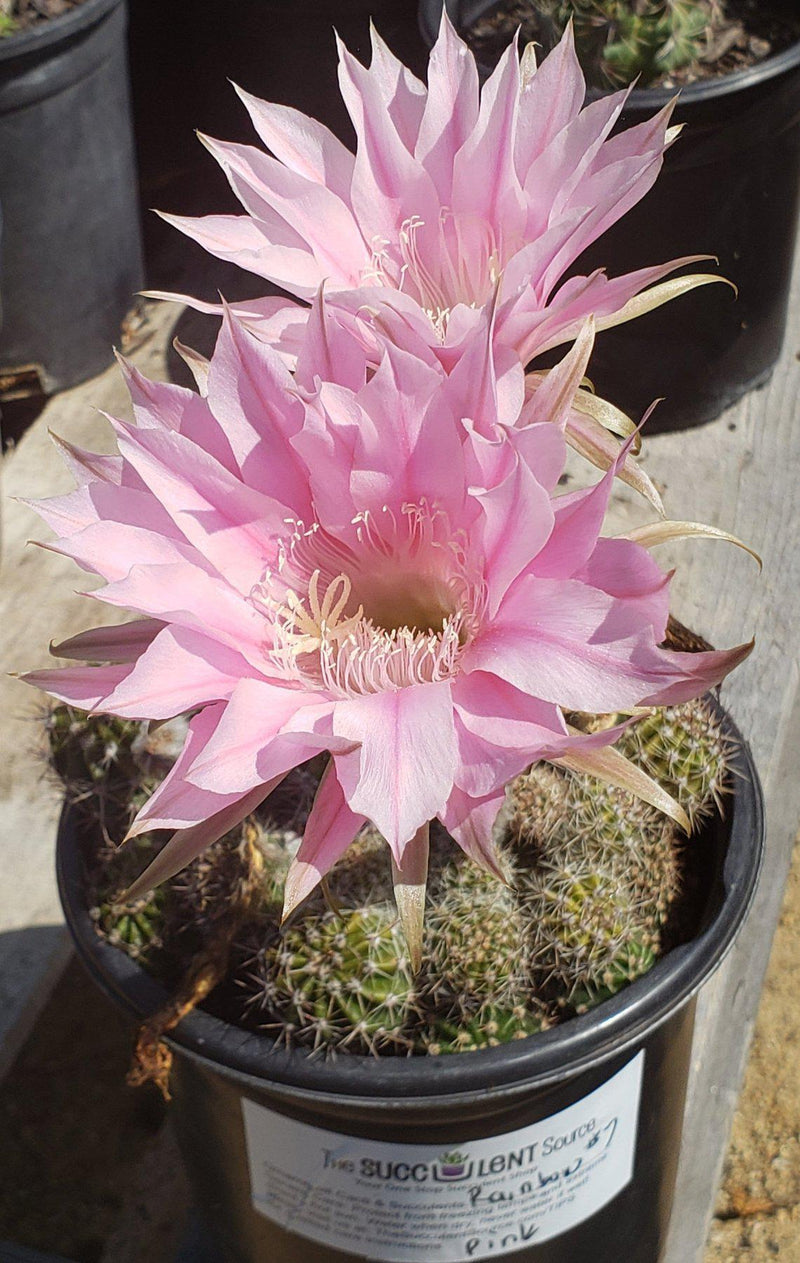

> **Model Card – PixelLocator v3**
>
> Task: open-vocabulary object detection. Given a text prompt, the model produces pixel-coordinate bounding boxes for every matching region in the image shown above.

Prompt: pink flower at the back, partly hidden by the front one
[149,15,713,364]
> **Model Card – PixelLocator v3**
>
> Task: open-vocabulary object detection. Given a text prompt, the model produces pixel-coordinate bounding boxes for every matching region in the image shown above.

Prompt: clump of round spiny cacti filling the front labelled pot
[49,701,729,1053]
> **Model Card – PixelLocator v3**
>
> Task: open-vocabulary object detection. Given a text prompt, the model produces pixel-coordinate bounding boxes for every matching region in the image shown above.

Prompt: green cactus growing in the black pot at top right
[540,0,724,87]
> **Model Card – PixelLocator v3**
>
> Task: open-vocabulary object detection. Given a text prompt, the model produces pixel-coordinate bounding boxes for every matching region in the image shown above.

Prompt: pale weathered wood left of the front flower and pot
[0,303,179,1075]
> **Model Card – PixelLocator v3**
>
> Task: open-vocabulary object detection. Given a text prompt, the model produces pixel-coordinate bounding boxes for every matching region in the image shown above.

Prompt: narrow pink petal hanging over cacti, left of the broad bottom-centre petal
[283,763,365,919]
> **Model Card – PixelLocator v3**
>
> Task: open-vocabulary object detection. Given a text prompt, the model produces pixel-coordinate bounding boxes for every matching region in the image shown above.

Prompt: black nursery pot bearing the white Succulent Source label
[58,719,763,1263]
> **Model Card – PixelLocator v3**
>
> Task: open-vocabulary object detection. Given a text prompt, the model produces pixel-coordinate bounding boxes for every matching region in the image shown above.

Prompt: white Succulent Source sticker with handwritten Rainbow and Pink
[243,1052,645,1263]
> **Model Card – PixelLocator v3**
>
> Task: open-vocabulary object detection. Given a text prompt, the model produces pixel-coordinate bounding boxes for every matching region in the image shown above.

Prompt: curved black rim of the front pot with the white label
[57,702,765,1109]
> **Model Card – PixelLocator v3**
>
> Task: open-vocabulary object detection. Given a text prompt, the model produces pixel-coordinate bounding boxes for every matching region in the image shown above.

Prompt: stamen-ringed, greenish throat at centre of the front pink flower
[252,504,484,697]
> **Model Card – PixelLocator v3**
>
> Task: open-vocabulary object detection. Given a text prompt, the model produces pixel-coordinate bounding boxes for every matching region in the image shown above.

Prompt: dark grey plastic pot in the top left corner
[0,0,142,394]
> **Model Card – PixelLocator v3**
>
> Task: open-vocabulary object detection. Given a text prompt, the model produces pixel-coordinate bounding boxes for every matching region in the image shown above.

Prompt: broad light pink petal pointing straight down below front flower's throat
[334,682,458,860]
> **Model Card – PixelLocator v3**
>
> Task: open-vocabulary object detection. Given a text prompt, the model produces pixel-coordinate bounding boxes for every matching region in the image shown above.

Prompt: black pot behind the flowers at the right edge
[420,0,800,432]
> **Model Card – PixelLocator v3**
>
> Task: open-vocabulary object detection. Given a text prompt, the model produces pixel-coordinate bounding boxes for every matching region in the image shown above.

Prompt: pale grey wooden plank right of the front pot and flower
[599,258,800,1263]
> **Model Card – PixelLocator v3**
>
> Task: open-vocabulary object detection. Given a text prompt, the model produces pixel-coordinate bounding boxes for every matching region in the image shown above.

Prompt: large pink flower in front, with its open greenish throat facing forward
[28,304,747,954]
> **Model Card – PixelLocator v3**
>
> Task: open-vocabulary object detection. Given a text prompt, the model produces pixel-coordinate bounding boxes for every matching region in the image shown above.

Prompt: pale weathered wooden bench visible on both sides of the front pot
[0,253,800,1263]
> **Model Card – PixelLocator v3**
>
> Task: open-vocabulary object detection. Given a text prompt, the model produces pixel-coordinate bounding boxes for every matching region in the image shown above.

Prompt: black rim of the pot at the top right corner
[417,0,800,111]
